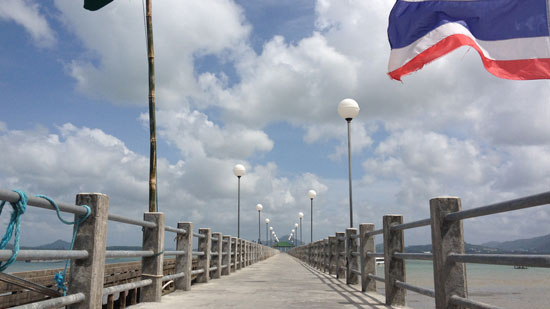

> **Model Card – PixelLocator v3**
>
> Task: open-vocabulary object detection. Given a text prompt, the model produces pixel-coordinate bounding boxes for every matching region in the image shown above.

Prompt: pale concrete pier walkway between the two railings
[131,254,389,309]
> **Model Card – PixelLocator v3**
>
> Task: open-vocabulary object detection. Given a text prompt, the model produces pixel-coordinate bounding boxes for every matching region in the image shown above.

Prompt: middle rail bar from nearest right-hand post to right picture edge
[447,253,550,267]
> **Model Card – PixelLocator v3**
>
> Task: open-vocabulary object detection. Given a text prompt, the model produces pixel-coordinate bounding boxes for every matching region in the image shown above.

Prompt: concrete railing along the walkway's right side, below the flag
[289,192,550,309]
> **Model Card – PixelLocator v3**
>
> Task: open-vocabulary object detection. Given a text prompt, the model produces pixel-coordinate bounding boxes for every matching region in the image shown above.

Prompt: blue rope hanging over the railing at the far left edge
[0,190,28,272]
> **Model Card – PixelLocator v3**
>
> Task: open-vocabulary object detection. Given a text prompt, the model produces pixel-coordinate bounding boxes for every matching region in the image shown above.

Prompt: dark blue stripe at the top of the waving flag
[388,0,549,48]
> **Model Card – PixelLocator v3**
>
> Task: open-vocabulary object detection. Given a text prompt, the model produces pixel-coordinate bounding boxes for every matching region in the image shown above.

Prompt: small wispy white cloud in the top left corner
[0,0,57,48]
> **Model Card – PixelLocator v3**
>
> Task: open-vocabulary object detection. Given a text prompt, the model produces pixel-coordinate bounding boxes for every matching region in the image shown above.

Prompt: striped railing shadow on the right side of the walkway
[296,259,391,309]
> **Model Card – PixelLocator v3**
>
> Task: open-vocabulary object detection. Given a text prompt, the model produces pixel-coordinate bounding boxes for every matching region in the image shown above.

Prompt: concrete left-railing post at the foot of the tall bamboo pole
[140,212,165,302]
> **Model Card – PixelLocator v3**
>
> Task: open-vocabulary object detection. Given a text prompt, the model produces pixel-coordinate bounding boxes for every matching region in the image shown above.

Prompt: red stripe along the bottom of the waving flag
[388,34,550,81]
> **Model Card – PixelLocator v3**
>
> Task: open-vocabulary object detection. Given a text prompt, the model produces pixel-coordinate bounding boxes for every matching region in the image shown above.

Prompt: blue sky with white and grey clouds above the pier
[0,0,550,244]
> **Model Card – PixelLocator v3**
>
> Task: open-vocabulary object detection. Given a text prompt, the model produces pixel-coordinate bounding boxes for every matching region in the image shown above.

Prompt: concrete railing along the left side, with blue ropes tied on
[0,190,279,308]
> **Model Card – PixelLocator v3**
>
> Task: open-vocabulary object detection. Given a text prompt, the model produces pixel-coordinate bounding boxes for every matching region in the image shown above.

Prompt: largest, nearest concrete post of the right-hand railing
[430,197,468,309]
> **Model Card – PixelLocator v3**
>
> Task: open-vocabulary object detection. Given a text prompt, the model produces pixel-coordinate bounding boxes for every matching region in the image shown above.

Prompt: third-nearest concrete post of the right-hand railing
[359,223,376,292]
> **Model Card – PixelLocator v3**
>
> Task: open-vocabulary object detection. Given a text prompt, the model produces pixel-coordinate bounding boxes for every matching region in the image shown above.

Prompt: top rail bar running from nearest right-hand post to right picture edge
[445,192,550,221]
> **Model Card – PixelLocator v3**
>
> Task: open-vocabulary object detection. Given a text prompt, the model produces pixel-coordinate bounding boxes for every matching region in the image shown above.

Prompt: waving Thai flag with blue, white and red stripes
[388,0,550,80]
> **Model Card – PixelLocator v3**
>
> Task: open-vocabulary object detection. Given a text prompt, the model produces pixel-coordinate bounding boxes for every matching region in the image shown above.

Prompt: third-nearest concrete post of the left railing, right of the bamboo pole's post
[175,222,193,291]
